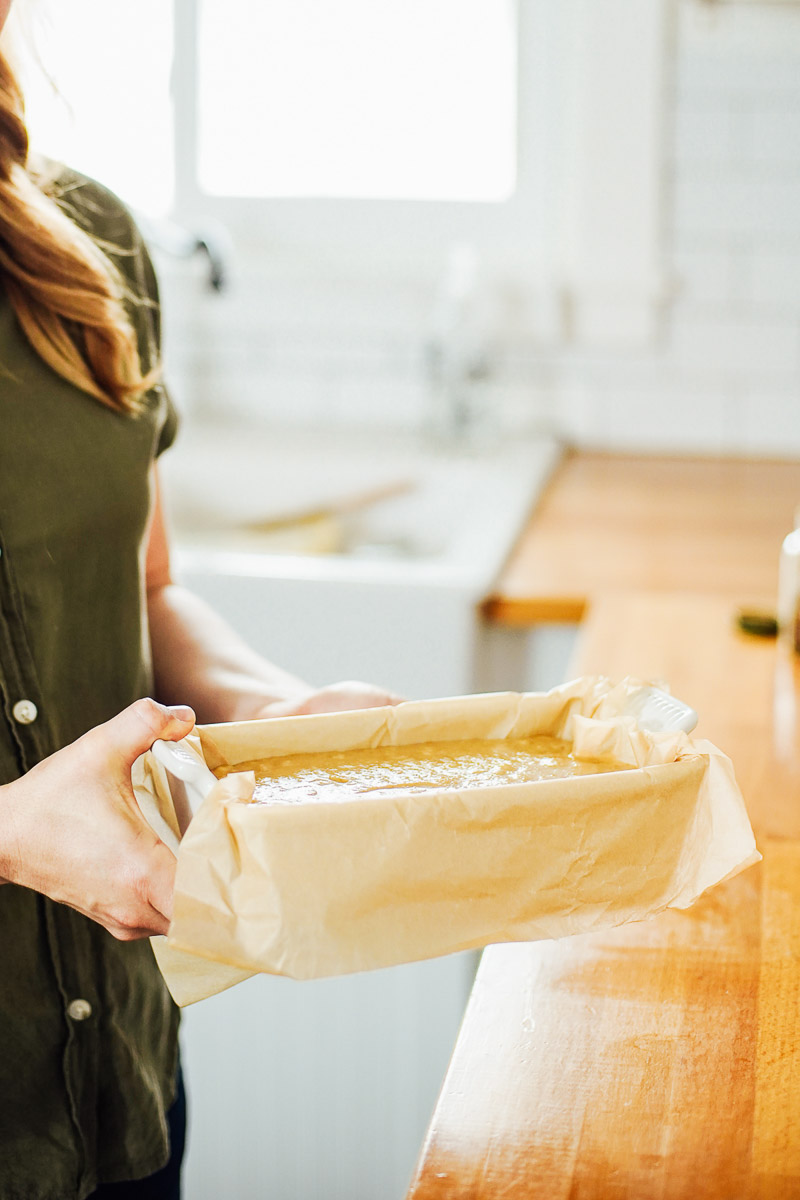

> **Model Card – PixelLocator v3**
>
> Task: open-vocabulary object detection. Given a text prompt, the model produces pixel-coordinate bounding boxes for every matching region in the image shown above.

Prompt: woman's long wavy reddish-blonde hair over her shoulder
[0,53,158,412]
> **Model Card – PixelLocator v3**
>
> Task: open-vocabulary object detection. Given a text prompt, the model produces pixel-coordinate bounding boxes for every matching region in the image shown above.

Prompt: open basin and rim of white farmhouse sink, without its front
[163,426,559,599]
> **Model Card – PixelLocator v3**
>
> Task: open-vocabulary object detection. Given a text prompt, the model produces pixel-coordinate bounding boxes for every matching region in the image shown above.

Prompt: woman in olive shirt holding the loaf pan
[0,0,392,1200]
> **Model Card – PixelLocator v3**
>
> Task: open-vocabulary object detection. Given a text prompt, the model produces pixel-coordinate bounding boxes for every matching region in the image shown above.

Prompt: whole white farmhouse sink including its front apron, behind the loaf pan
[163,426,559,698]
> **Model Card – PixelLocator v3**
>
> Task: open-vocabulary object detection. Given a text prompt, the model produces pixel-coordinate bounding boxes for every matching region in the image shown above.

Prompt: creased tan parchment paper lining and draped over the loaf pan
[134,678,760,1004]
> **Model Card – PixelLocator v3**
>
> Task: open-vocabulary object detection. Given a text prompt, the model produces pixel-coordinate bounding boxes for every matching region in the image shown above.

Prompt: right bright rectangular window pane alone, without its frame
[197,0,517,202]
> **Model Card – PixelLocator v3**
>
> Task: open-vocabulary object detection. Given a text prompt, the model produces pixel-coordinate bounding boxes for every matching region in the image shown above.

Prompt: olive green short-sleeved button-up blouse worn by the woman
[0,173,178,1200]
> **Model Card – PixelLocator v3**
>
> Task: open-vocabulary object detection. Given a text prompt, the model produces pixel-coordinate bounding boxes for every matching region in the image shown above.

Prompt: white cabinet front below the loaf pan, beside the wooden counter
[182,954,476,1200]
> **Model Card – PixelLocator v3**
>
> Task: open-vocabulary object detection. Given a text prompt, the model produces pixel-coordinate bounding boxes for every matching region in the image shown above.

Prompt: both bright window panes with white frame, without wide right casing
[12,0,548,270]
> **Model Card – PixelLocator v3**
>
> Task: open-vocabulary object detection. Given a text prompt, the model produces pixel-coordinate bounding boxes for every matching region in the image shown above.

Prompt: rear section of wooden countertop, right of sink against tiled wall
[486,454,800,625]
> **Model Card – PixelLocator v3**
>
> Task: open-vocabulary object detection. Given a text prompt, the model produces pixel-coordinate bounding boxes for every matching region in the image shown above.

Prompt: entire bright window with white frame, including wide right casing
[12,0,669,338]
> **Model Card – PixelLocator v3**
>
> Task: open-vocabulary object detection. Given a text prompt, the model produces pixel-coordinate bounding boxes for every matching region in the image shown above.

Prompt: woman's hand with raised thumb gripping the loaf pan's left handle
[0,700,194,941]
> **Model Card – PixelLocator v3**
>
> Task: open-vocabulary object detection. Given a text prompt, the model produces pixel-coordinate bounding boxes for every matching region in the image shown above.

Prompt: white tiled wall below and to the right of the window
[155,0,800,456]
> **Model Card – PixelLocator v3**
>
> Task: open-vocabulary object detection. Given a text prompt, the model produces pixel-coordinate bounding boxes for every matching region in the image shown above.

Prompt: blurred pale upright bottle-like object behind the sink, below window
[425,244,489,449]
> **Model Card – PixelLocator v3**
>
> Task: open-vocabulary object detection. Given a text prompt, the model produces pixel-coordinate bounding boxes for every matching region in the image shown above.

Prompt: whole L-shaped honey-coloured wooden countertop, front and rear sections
[409,457,800,1200]
